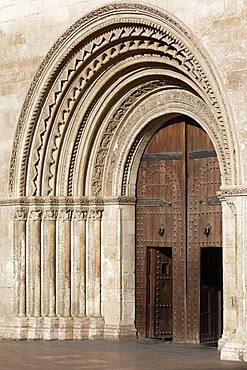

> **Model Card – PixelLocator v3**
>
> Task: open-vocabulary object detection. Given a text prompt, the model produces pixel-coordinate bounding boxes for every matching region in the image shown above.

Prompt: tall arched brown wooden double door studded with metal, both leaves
[136,118,221,342]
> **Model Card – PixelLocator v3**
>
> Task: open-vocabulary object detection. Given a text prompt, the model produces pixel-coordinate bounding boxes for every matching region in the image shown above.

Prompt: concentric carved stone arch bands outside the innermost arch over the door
[9,4,239,196]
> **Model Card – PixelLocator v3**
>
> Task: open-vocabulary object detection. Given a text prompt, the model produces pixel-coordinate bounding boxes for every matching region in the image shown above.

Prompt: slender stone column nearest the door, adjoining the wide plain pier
[87,206,104,339]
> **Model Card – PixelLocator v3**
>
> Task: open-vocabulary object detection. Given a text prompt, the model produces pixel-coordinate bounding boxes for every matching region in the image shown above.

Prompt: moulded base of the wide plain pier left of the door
[104,323,137,340]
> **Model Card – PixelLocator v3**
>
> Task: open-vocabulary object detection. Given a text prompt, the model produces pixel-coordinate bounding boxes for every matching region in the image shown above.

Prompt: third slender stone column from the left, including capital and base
[42,209,58,340]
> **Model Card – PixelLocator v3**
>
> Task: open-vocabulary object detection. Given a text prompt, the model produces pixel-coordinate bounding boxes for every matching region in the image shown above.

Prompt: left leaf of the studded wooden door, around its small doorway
[136,122,186,339]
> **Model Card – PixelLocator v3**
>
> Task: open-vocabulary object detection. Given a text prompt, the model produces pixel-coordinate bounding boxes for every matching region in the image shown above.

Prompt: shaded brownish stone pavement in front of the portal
[0,340,247,370]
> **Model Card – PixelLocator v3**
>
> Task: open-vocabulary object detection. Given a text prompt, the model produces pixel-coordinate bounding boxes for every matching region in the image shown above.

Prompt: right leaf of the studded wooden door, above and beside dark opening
[186,122,222,342]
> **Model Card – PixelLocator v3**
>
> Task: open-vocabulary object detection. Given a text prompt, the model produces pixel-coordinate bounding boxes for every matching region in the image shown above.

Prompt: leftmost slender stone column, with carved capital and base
[14,208,28,339]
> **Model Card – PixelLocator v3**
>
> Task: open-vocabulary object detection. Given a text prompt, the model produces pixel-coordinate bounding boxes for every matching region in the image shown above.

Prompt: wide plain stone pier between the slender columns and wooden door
[102,197,136,339]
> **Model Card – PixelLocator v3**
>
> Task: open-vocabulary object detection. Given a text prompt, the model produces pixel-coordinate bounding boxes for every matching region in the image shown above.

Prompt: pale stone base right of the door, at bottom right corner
[220,334,247,361]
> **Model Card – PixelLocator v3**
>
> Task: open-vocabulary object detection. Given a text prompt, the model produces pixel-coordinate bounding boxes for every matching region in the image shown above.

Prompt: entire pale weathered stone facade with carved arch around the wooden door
[0,0,247,360]
